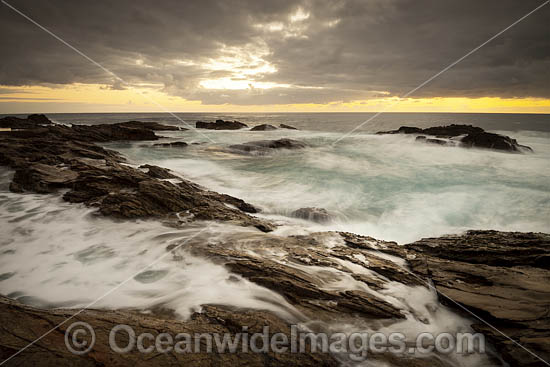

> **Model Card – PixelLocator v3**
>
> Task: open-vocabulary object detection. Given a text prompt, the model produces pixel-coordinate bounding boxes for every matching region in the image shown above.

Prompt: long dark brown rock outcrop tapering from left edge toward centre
[0,115,273,231]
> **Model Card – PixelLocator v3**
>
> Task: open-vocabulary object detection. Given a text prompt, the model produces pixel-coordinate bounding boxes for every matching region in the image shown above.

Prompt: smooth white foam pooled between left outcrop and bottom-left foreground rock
[0,185,297,318]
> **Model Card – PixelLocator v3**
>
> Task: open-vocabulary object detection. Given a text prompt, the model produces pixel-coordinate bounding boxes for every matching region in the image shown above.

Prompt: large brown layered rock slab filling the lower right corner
[406,231,550,366]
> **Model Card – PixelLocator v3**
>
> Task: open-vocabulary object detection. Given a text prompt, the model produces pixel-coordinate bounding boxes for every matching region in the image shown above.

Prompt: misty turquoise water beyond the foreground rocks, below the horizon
[95,115,550,243]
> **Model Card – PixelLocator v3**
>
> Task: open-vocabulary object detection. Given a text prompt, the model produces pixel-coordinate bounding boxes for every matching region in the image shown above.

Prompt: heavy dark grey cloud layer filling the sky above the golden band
[0,0,550,104]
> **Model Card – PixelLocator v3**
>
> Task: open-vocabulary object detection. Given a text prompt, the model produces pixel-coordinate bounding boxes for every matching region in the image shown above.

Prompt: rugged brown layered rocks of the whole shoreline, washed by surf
[0,115,550,367]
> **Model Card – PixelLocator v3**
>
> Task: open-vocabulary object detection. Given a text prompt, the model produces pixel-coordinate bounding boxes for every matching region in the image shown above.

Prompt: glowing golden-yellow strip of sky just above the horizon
[0,84,550,113]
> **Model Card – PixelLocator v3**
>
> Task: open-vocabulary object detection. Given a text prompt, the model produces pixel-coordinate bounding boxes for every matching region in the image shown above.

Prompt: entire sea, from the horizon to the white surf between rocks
[0,113,550,366]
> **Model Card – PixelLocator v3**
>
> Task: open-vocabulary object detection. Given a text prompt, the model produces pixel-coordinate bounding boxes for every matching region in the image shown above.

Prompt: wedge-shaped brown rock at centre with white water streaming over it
[192,233,405,322]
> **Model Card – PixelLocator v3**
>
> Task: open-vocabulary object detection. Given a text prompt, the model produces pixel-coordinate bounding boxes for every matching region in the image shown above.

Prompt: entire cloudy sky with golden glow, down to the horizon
[0,0,550,113]
